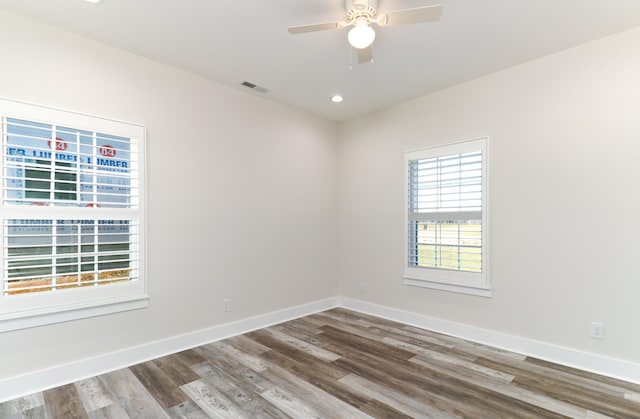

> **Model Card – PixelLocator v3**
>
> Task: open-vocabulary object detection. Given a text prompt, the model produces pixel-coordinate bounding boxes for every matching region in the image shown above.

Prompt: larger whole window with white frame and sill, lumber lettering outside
[0,99,148,331]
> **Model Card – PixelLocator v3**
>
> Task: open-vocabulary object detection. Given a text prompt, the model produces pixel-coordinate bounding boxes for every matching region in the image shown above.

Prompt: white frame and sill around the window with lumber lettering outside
[0,98,149,332]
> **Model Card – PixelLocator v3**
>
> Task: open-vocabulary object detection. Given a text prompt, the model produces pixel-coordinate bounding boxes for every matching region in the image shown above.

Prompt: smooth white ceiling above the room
[0,0,640,121]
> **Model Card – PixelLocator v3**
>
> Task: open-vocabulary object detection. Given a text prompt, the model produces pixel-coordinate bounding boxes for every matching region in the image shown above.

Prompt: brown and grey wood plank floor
[0,309,640,419]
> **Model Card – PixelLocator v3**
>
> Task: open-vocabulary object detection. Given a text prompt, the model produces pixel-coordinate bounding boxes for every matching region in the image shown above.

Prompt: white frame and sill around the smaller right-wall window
[402,137,492,297]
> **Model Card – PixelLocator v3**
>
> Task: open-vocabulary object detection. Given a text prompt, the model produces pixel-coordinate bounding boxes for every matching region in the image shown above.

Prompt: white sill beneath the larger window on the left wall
[0,295,149,333]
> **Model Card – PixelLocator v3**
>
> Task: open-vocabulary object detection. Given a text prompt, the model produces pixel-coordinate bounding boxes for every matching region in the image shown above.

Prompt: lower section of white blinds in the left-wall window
[2,219,140,295]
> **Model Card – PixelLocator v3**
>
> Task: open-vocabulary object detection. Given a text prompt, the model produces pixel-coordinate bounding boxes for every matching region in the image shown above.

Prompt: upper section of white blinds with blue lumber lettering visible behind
[2,117,139,208]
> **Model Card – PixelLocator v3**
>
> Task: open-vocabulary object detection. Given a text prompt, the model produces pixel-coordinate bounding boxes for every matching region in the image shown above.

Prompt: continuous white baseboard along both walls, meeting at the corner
[0,297,640,403]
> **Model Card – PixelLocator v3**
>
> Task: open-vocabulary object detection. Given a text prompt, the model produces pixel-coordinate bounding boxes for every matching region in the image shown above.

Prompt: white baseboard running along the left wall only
[0,297,338,403]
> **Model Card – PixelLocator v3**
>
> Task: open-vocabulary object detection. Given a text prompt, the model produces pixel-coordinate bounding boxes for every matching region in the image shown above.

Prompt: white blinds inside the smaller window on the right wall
[407,143,484,273]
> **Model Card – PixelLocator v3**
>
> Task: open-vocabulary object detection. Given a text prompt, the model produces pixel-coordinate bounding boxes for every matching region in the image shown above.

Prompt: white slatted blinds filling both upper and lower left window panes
[1,116,142,297]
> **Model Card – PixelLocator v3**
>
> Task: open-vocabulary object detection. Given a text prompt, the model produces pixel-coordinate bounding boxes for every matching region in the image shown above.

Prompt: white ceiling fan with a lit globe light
[288,0,442,64]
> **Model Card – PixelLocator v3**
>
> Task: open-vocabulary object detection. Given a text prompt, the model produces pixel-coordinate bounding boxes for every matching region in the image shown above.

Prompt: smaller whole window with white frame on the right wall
[403,138,491,296]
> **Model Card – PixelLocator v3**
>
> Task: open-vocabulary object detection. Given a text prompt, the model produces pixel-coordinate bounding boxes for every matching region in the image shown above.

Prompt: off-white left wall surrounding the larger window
[0,11,337,380]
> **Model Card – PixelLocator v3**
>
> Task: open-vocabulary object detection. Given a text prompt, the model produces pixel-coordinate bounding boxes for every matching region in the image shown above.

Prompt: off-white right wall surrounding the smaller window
[338,28,640,362]
